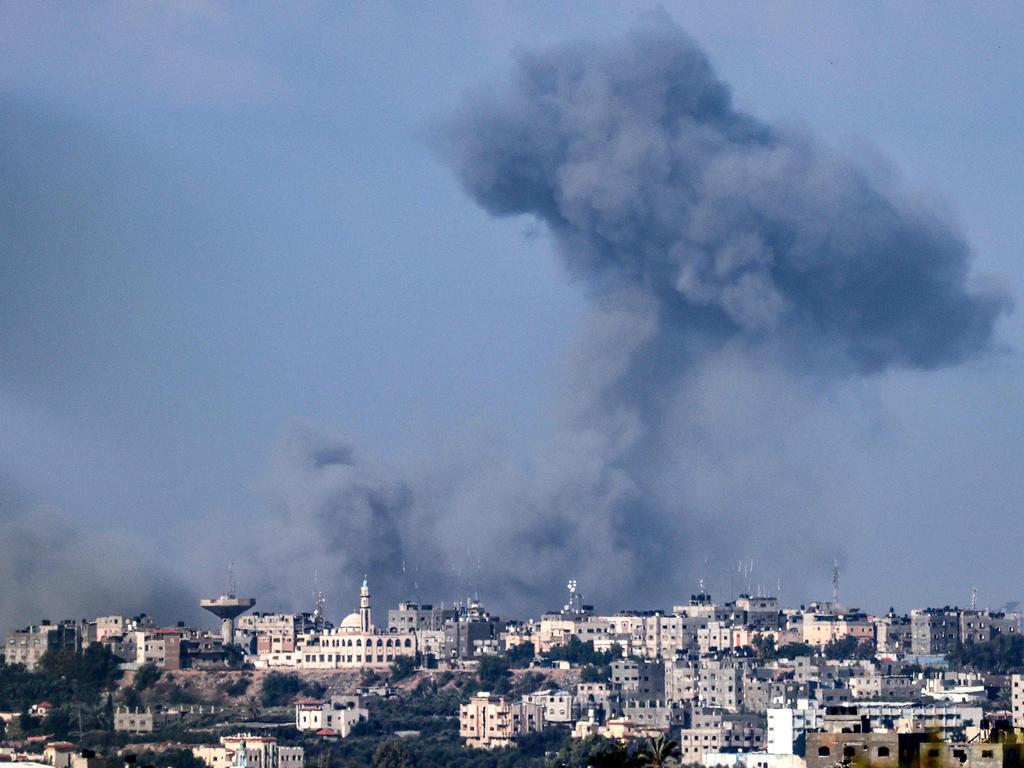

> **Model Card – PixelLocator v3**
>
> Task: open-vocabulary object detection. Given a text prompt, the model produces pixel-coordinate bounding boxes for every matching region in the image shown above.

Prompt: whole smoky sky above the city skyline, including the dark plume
[0,4,1024,627]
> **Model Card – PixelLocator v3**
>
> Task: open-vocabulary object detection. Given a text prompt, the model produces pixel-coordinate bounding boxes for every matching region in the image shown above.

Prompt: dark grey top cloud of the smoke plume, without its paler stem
[438,17,1008,372]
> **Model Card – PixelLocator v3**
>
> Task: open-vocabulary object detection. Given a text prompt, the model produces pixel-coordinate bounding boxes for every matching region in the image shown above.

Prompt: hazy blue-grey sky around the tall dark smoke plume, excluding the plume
[0,2,1024,626]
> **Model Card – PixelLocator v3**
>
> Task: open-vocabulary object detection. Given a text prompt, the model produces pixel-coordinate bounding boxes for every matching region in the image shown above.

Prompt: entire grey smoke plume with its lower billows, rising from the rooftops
[258,17,1009,609]
